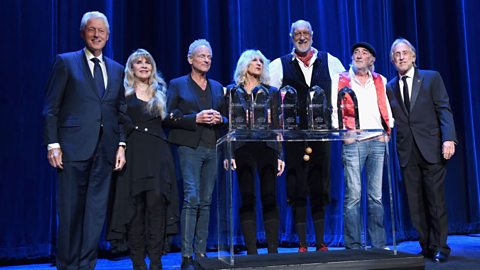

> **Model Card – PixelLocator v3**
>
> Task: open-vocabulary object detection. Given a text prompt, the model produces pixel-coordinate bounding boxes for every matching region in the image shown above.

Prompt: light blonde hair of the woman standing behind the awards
[233,50,270,85]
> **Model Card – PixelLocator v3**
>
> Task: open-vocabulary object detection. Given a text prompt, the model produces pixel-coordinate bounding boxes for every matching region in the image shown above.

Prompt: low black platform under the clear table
[196,250,425,270]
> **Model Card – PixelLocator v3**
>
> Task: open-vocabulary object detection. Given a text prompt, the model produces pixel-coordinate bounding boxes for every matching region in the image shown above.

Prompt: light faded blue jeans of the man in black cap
[342,140,385,249]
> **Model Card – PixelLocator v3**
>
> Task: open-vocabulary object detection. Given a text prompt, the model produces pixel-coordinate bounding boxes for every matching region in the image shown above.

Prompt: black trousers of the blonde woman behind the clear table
[235,142,278,224]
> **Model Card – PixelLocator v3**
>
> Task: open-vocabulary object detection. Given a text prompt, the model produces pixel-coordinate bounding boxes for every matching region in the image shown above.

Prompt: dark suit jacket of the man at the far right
[387,69,457,167]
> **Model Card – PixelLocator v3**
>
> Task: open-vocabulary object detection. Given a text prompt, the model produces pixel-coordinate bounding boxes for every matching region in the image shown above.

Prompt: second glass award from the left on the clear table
[251,85,272,130]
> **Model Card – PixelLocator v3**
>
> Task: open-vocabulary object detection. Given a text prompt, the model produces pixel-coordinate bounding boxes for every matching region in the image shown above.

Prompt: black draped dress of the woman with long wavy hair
[107,94,178,240]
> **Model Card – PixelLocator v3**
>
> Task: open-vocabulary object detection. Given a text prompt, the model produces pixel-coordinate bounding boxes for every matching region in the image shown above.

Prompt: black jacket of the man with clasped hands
[166,74,228,148]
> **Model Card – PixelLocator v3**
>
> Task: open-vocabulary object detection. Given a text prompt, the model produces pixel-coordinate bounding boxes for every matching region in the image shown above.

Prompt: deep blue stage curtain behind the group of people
[0,0,480,262]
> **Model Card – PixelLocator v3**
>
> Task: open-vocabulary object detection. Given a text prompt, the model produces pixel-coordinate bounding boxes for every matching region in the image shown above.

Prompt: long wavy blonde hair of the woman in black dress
[123,49,167,119]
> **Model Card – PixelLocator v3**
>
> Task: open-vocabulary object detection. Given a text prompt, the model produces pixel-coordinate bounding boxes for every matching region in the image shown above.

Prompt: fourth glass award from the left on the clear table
[307,85,329,130]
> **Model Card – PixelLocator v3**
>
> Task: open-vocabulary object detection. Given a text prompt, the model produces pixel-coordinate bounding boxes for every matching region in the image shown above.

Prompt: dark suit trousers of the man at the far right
[402,144,450,254]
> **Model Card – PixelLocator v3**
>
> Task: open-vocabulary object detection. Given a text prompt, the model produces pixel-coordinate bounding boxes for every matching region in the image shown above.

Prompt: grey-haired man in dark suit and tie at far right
[387,39,456,262]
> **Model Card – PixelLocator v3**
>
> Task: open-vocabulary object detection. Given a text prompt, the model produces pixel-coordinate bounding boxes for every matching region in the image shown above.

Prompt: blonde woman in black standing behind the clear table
[228,50,285,254]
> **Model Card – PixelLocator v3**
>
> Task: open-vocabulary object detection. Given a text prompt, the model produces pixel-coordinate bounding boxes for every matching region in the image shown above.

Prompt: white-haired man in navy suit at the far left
[43,11,125,269]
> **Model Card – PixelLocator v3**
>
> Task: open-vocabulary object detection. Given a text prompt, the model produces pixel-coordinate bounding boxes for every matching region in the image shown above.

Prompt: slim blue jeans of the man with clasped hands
[178,146,217,256]
